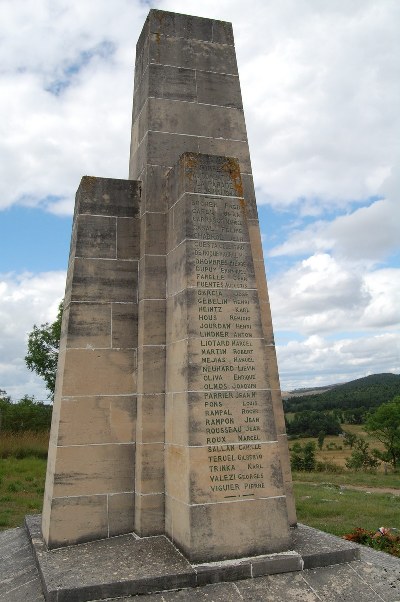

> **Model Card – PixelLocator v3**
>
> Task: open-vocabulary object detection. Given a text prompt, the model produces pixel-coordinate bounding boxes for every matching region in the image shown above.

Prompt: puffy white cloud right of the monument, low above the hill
[269,253,400,335]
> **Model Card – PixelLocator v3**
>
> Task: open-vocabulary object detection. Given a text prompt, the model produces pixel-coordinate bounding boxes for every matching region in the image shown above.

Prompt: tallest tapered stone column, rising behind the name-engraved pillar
[129,10,296,534]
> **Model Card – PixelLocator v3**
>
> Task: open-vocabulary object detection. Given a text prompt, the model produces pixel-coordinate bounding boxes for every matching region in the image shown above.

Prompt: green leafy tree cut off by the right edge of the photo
[365,395,400,470]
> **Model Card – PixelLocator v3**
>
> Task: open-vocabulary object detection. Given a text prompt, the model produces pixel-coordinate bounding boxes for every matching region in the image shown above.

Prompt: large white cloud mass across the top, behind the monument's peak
[0,0,400,214]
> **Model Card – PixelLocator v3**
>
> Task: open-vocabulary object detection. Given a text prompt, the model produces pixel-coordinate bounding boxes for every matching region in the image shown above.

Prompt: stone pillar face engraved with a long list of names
[167,163,282,503]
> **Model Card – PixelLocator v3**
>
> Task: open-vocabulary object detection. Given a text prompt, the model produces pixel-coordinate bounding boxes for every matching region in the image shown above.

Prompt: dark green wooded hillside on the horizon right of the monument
[284,373,400,412]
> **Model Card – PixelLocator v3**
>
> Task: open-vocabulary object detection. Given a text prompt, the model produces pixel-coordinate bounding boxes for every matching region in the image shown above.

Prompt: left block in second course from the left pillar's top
[76,215,117,259]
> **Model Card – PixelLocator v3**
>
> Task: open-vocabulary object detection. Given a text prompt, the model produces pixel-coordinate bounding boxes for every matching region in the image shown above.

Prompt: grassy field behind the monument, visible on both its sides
[0,427,400,535]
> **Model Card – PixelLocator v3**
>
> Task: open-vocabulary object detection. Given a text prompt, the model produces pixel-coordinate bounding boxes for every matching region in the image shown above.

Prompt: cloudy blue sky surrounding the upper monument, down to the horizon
[0,0,400,400]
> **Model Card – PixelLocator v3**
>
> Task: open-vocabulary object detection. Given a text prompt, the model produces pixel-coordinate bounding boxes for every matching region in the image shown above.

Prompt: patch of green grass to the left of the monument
[0,457,46,530]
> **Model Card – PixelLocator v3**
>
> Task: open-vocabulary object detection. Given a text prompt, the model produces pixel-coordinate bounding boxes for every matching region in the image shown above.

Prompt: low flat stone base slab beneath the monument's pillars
[25,515,360,602]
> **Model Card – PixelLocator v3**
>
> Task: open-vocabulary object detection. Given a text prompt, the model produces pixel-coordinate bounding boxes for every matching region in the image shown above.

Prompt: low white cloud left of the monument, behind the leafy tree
[0,272,66,399]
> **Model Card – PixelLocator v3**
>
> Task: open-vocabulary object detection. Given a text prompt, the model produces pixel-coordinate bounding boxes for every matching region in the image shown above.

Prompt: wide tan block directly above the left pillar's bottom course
[53,443,135,498]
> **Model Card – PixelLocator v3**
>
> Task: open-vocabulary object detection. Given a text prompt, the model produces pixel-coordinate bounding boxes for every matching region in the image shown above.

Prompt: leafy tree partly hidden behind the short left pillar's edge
[25,302,63,399]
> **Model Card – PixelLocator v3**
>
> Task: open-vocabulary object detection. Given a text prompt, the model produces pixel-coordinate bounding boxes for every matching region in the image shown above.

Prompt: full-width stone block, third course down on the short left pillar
[71,257,138,303]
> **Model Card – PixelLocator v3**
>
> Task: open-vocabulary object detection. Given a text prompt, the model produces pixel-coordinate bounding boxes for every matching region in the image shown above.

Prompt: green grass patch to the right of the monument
[294,474,400,536]
